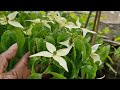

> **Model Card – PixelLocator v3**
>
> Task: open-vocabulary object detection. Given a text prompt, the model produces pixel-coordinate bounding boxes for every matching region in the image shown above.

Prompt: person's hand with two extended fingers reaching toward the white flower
[0,44,30,79]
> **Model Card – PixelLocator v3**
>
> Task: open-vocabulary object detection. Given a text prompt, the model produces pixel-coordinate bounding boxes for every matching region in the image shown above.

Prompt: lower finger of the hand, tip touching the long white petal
[15,52,30,68]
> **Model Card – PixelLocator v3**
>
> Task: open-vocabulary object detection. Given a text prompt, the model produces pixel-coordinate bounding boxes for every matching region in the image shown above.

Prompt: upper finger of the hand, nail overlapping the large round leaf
[1,43,18,61]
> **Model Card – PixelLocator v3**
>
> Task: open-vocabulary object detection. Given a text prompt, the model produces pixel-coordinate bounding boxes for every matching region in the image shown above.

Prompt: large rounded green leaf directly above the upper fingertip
[1,29,25,50]
